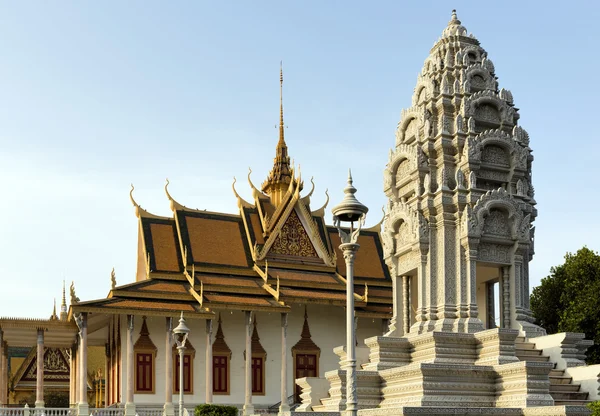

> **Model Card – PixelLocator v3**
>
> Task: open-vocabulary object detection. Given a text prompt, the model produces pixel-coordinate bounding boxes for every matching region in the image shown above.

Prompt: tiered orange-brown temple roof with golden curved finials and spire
[76,72,392,318]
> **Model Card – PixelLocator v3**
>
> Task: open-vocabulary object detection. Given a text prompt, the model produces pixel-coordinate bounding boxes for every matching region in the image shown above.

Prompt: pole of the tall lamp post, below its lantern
[340,243,359,416]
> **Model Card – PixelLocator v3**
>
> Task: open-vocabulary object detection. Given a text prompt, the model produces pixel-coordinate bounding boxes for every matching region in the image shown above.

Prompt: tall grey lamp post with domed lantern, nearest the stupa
[331,171,369,416]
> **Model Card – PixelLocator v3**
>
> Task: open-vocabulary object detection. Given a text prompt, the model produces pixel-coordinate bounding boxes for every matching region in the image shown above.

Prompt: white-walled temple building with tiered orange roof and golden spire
[58,66,392,414]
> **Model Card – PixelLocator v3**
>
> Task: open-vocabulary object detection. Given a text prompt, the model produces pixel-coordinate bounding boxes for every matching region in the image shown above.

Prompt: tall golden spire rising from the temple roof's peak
[262,61,292,205]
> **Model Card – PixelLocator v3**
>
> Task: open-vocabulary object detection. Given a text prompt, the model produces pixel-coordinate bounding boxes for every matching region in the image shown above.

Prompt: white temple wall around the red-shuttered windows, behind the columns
[121,305,382,406]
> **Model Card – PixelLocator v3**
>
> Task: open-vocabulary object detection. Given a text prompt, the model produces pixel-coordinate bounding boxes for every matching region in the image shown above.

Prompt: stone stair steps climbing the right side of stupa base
[515,336,590,406]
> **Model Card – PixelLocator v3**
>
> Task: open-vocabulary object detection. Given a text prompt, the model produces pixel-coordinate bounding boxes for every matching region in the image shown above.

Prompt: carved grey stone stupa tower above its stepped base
[383,11,544,337]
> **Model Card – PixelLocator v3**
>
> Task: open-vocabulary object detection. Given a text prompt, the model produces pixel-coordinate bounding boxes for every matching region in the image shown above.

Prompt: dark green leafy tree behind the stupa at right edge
[531,247,600,364]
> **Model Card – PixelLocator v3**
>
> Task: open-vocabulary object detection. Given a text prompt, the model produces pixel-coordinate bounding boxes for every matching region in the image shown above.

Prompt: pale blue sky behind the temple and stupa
[0,0,600,318]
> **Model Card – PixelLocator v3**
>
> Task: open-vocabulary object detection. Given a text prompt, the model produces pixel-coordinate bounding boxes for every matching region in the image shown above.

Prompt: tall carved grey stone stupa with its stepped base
[297,11,600,416]
